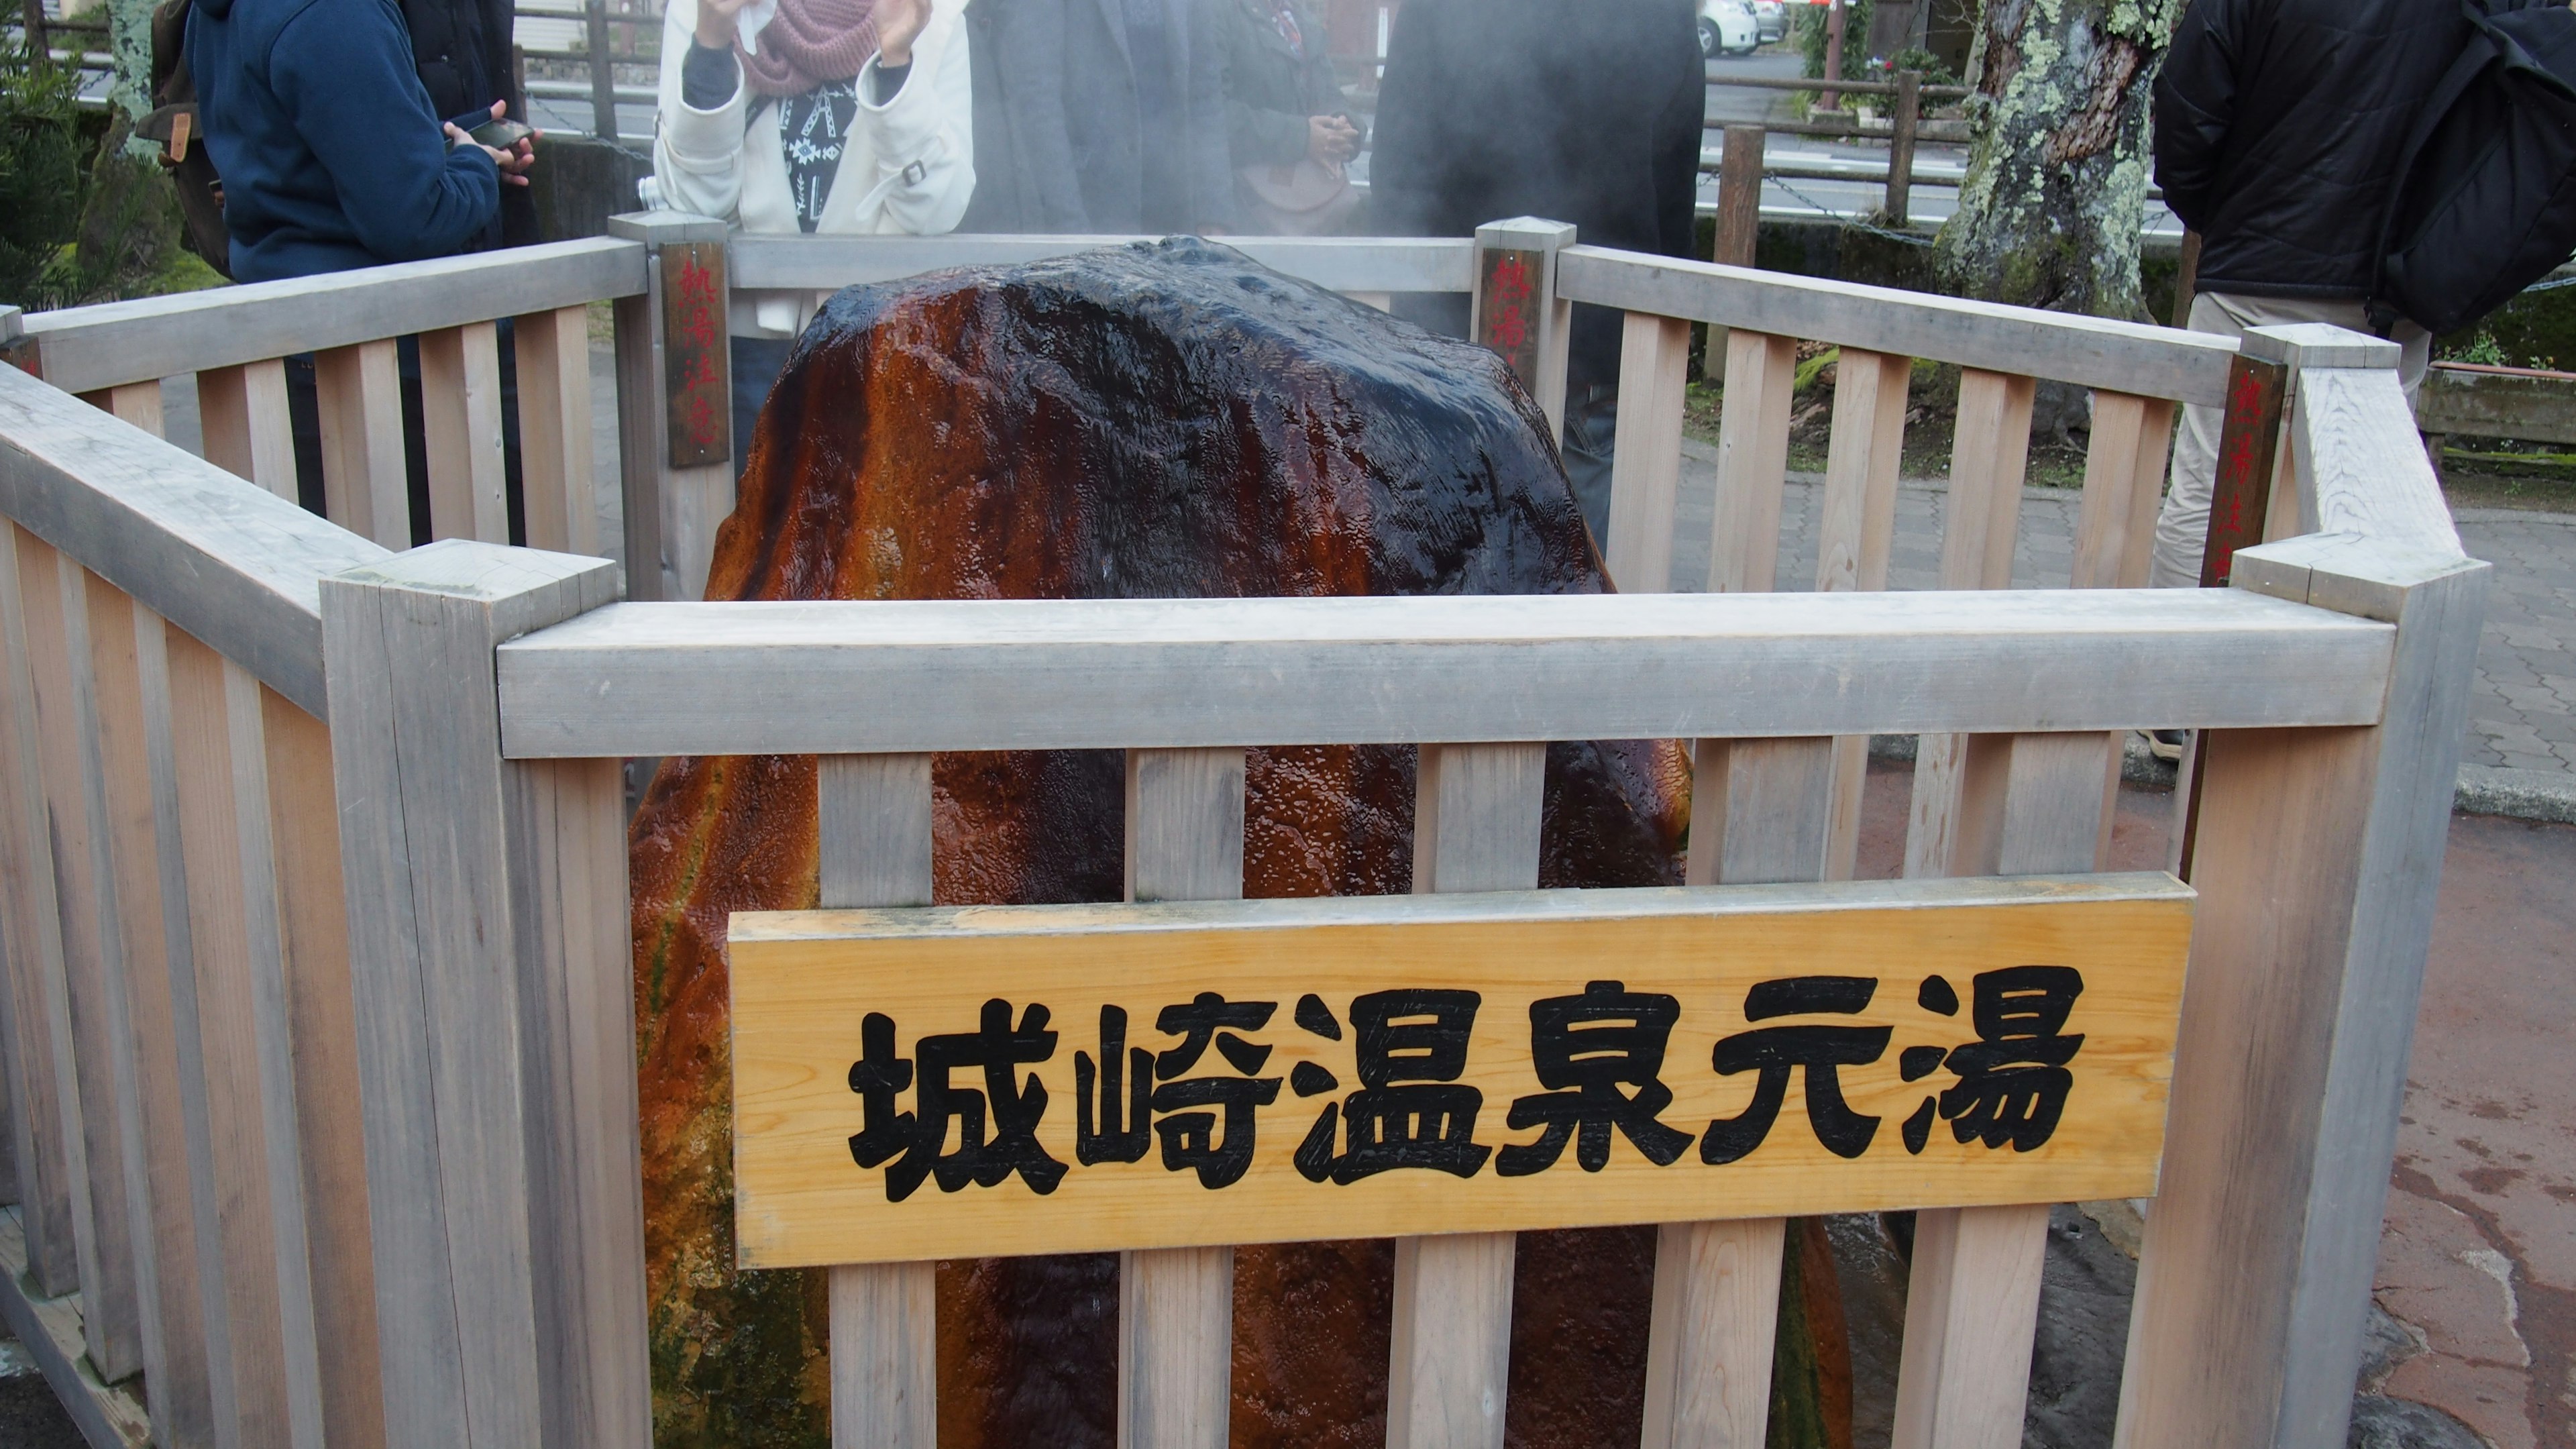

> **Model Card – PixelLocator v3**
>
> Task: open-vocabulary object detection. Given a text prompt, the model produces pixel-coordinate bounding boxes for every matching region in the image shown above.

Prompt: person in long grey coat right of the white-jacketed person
[958,0,1234,235]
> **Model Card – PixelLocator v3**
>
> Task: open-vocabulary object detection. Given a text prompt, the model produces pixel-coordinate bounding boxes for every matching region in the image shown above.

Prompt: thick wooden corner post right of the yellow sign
[2117,536,2491,1449]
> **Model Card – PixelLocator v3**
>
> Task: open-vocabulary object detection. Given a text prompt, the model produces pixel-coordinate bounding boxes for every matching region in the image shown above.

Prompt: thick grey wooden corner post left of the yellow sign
[322,541,649,1449]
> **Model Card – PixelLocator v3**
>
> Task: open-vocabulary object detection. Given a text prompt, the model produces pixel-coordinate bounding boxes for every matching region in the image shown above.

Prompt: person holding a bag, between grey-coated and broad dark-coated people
[1221,0,1362,235]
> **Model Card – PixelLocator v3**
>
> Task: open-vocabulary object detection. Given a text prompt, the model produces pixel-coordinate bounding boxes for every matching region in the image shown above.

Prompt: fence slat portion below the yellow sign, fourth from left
[1644,1217,1788,1449]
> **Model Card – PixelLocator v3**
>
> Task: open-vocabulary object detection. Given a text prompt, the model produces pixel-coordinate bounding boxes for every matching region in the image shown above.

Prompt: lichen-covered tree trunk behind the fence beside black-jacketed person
[1935,0,2184,322]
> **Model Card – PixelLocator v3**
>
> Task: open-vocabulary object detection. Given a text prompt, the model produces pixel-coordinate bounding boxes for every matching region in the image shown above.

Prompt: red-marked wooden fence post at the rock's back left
[608,211,734,601]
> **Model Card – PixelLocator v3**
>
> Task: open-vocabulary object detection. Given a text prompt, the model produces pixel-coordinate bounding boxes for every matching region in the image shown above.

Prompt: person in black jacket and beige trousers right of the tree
[2153,0,2471,588]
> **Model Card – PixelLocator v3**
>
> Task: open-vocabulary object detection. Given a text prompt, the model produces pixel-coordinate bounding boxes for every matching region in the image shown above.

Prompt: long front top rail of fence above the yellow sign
[500,580,2393,758]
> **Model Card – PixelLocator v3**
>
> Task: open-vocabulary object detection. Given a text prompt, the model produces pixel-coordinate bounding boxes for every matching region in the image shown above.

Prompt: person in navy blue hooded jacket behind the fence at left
[188,0,531,281]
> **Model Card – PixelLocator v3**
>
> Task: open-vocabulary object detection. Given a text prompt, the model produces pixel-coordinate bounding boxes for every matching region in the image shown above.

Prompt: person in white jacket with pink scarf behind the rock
[654,0,974,453]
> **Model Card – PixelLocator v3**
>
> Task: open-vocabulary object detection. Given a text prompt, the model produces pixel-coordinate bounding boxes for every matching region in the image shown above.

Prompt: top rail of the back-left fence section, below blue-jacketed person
[25,237,644,392]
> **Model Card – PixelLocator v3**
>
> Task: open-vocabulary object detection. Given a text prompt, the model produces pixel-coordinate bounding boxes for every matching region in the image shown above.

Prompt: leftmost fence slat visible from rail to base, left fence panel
[10,529,144,1379]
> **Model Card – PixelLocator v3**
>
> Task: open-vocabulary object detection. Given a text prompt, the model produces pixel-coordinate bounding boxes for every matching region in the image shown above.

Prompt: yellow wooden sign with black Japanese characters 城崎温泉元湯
[732,874,2192,1269]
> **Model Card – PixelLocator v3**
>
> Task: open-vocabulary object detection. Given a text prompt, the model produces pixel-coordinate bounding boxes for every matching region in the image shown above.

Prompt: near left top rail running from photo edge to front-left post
[0,366,389,719]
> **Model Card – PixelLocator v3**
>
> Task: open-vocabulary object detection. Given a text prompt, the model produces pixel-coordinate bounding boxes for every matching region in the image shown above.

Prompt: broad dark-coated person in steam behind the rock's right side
[1368,0,1708,539]
